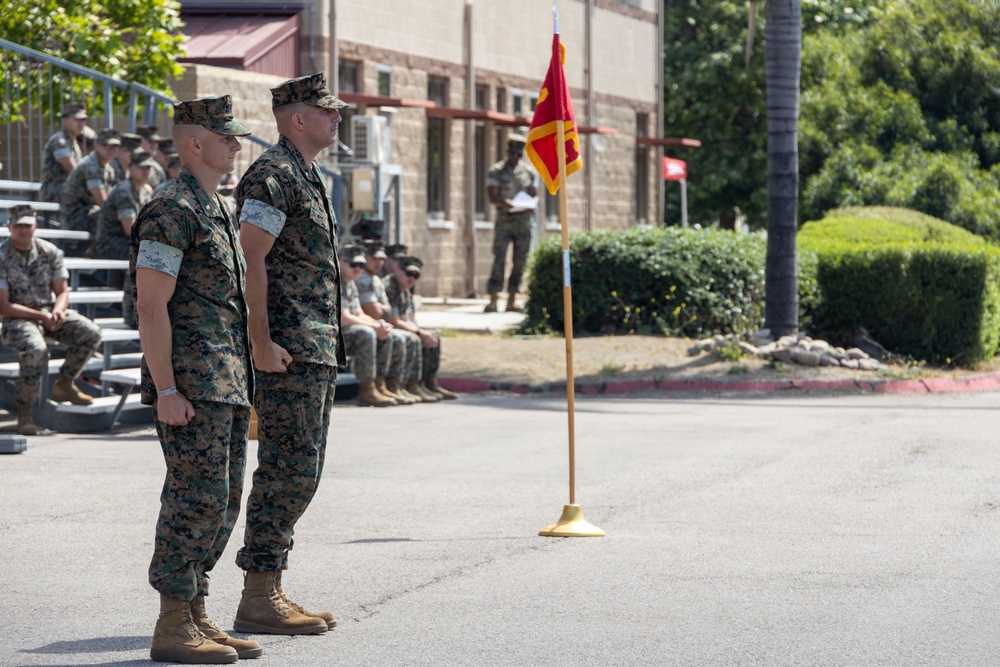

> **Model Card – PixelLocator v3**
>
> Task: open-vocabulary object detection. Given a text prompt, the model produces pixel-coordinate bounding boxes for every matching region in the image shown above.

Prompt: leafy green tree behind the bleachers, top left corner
[0,0,184,112]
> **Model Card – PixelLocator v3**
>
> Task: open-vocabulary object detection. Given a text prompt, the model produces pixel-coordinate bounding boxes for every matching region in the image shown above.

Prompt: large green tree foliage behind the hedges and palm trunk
[664,0,1000,239]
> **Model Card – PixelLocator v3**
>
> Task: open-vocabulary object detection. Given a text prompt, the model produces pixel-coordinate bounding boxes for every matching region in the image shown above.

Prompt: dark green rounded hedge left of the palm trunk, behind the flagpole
[525,227,765,337]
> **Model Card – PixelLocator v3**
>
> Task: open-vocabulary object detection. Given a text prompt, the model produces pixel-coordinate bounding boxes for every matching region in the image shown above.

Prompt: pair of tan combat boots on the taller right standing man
[233,572,326,635]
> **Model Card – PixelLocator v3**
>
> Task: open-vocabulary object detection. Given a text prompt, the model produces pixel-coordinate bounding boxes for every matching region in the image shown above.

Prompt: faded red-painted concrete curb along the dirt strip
[439,372,1000,396]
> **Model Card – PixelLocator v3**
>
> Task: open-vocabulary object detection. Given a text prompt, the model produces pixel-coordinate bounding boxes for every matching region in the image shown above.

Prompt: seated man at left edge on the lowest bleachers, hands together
[0,205,101,435]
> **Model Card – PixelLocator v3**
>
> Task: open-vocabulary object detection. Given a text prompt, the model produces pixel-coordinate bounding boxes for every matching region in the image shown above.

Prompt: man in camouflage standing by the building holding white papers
[486,135,537,312]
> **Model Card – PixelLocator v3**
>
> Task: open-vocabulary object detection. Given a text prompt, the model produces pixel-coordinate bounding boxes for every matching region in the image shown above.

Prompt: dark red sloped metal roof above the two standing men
[178,13,299,77]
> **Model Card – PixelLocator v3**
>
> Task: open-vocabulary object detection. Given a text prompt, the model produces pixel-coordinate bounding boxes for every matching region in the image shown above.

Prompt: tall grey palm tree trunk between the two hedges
[764,0,802,338]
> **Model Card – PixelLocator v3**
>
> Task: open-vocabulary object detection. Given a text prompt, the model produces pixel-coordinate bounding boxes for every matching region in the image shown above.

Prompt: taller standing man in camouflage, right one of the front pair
[234,74,345,634]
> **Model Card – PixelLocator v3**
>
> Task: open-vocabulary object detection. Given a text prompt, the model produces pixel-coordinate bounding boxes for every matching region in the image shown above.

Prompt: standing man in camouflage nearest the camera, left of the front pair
[129,96,261,663]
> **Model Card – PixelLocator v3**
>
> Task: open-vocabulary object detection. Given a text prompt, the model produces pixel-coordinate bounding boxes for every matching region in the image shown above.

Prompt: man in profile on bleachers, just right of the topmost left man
[60,130,121,234]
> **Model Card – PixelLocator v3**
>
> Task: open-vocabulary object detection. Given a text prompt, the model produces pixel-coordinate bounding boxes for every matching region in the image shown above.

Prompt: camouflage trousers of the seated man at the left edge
[0,310,101,406]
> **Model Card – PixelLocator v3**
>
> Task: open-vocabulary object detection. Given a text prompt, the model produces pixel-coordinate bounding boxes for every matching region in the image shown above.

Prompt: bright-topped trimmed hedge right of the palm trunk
[798,209,1000,367]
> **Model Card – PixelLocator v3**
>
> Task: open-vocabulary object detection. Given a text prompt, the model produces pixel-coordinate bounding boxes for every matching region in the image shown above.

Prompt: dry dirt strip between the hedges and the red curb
[440,335,1000,387]
